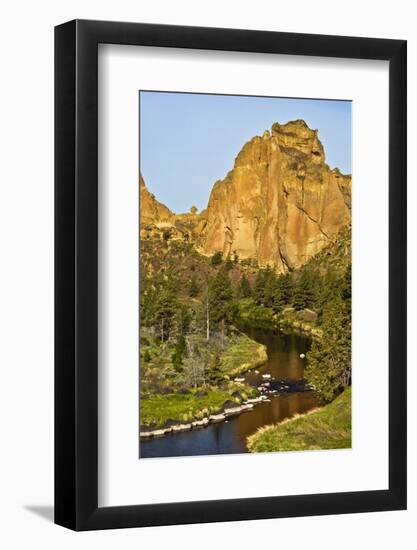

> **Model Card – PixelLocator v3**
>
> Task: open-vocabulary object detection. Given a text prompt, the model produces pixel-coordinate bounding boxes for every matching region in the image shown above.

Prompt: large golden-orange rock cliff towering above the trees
[196,120,351,271]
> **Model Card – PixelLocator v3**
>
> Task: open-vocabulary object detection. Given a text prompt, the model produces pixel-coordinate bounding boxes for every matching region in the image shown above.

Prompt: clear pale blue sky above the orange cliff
[140,92,352,213]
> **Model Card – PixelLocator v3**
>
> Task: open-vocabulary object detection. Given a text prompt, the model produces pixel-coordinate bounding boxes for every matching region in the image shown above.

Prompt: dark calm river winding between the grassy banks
[140,326,317,458]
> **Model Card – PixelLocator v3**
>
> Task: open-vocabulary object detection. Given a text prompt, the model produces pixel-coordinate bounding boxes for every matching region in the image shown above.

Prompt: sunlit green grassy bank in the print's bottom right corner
[247,388,352,453]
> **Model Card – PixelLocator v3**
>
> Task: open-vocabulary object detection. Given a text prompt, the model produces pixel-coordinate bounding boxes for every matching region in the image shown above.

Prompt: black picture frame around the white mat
[55,20,407,531]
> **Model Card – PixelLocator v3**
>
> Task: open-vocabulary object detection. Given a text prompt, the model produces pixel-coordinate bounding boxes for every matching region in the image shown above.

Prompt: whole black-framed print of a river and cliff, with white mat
[55,20,406,530]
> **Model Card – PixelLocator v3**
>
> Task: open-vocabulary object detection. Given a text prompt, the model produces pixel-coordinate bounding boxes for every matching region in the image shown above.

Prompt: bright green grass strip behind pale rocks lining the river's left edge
[140,384,254,429]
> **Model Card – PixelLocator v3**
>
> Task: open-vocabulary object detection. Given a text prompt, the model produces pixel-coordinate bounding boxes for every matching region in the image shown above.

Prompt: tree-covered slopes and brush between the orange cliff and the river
[140,222,351,434]
